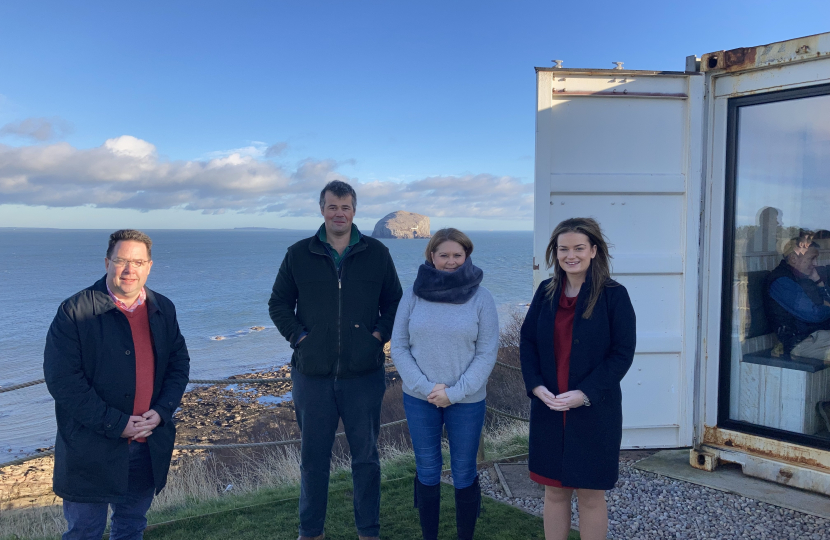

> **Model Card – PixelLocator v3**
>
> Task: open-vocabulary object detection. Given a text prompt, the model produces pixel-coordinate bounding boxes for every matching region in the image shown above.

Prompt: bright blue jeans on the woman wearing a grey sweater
[403,394,487,489]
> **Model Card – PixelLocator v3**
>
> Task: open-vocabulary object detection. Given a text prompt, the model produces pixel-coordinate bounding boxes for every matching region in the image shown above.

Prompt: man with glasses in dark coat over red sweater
[43,229,190,540]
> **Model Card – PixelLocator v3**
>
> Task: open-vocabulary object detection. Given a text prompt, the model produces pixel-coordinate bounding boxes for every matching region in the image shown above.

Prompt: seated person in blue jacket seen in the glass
[764,234,830,361]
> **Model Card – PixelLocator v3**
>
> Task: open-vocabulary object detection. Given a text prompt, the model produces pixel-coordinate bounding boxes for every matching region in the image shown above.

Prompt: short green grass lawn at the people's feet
[144,477,579,540]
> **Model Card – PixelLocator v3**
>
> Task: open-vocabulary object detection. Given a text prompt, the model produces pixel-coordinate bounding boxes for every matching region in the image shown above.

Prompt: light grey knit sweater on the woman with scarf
[392,286,499,403]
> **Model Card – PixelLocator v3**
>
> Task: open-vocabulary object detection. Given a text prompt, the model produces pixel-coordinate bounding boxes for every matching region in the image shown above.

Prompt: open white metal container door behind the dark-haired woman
[534,68,704,448]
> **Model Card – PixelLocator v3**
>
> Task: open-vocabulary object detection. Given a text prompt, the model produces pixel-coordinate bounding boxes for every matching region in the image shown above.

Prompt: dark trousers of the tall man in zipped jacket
[291,369,386,536]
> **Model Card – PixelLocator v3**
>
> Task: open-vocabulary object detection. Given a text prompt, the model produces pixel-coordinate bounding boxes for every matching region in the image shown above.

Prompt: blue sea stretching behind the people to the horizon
[0,228,533,463]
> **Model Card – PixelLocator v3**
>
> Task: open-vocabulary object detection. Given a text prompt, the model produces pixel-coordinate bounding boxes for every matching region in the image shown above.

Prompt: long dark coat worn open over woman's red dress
[521,274,636,490]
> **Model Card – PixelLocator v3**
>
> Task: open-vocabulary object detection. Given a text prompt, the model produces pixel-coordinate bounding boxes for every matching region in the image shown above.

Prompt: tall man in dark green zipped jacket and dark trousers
[268,180,402,540]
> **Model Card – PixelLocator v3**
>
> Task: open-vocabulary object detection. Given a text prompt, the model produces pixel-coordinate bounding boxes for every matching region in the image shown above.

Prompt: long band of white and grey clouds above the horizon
[0,135,533,220]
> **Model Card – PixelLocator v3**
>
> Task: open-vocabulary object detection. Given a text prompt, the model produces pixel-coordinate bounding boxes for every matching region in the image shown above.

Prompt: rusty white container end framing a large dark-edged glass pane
[701,33,830,456]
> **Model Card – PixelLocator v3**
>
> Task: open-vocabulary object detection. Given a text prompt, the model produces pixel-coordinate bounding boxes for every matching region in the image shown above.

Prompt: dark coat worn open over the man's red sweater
[43,278,190,503]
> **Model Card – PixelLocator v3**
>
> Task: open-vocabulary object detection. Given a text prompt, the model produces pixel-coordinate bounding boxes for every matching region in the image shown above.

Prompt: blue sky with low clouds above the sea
[0,0,830,230]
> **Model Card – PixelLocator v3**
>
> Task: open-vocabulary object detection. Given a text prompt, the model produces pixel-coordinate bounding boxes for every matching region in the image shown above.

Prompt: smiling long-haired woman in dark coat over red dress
[521,218,636,540]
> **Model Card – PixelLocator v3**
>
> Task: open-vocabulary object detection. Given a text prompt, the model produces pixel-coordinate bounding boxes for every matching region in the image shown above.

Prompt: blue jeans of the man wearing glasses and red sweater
[61,441,156,540]
